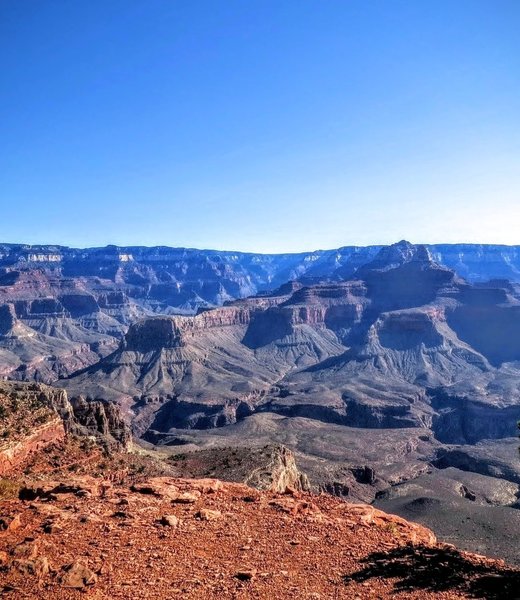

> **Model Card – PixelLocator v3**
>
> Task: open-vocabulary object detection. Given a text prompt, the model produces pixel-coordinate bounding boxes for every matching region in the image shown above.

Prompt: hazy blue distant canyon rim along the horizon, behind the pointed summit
[0,240,520,292]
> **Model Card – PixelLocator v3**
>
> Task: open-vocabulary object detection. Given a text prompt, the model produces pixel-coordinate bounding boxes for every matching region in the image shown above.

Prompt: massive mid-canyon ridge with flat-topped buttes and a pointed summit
[61,242,520,443]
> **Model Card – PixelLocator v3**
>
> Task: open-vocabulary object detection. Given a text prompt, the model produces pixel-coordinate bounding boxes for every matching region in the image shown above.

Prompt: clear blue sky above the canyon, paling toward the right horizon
[0,0,520,252]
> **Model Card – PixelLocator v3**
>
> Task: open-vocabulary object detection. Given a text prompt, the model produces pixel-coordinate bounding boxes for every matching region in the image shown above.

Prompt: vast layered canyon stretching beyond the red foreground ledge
[0,241,520,561]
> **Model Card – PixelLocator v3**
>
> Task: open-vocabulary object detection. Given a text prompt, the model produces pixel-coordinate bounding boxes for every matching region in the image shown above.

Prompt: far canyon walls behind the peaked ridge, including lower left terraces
[0,244,520,383]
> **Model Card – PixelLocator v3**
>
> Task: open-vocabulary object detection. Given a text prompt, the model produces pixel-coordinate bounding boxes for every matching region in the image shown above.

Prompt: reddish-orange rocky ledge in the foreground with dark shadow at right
[0,476,520,600]
